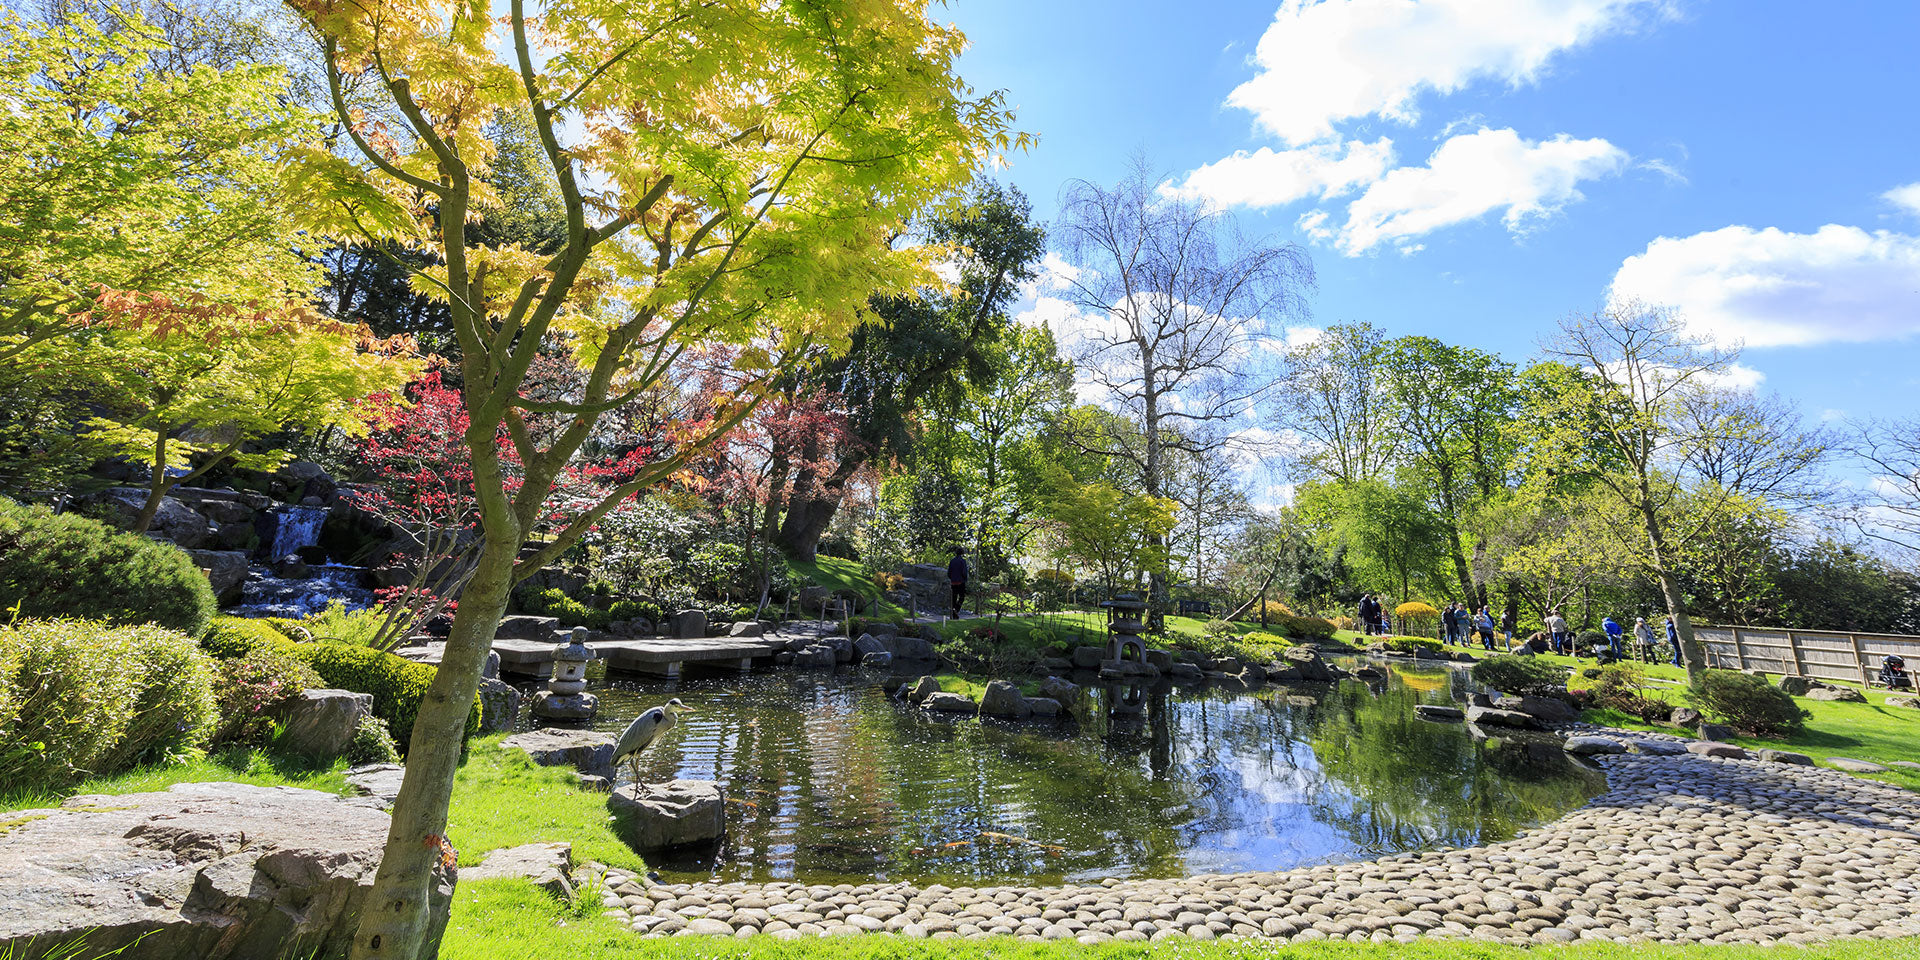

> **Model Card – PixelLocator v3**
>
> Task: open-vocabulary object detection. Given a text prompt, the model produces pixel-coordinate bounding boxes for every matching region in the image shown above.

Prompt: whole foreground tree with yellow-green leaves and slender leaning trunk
[290,0,1021,960]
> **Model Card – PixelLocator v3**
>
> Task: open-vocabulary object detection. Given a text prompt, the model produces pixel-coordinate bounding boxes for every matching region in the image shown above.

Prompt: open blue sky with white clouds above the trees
[945,0,1920,424]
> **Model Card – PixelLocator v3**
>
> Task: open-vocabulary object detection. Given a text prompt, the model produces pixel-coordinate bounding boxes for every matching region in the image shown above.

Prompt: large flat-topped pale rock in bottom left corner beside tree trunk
[0,783,453,960]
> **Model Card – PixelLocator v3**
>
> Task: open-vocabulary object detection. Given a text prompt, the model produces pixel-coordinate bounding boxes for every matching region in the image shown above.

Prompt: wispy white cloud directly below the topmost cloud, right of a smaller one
[1336,129,1626,255]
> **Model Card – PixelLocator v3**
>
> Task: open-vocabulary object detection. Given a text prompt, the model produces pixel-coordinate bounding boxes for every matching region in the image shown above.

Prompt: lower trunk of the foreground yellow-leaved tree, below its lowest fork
[351,536,520,960]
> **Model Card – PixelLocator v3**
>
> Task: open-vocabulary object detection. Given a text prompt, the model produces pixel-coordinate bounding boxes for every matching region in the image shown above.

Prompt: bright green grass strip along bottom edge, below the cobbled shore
[440,879,1920,960]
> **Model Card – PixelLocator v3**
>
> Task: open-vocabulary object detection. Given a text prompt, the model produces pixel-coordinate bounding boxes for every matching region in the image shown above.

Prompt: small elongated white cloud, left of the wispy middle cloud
[1160,136,1394,209]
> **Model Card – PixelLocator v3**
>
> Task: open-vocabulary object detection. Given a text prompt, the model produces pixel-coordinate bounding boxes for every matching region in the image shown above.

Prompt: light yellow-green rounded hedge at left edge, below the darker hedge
[0,618,219,793]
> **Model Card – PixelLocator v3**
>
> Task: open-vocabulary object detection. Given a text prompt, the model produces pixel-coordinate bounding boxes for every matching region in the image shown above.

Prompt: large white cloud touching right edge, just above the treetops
[1611,223,1920,348]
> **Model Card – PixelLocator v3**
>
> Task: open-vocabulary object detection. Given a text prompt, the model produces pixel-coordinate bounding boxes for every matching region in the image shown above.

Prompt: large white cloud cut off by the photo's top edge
[1227,0,1672,144]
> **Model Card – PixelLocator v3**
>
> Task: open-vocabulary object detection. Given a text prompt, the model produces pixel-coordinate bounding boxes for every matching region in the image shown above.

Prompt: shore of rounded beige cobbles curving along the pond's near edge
[603,755,1920,943]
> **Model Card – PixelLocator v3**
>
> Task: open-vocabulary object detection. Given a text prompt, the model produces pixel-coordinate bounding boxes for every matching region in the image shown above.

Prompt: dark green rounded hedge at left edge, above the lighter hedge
[0,497,215,637]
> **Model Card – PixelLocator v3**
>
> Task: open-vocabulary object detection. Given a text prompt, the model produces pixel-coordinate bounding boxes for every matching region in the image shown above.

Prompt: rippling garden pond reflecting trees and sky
[514,666,1605,885]
